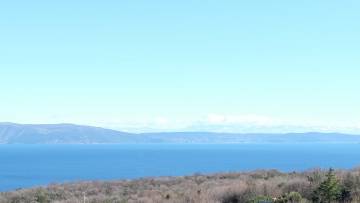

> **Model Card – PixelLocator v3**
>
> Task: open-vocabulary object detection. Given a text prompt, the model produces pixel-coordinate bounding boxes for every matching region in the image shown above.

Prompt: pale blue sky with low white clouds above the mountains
[0,0,360,133]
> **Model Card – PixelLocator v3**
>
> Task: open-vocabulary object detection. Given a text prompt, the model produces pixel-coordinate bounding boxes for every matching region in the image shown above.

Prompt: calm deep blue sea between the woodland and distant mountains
[0,144,360,191]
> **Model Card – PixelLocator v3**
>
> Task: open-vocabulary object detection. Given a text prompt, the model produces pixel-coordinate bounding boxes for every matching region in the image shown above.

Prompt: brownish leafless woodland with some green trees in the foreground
[0,169,360,203]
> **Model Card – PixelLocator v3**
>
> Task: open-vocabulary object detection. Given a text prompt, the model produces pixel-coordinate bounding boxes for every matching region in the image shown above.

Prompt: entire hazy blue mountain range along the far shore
[0,123,360,144]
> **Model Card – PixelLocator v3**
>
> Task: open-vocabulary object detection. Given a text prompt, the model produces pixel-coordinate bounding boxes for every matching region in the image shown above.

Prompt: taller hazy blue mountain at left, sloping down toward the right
[0,123,133,144]
